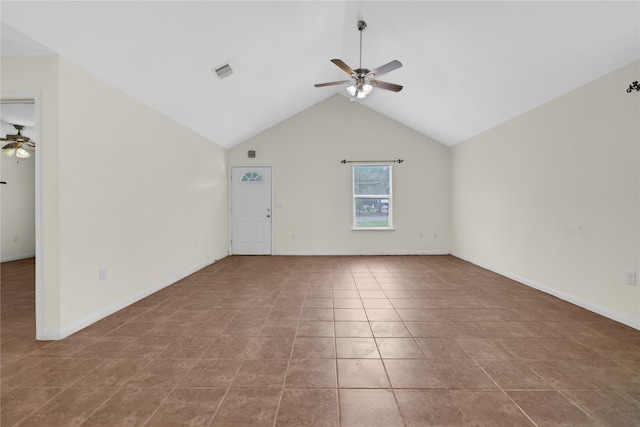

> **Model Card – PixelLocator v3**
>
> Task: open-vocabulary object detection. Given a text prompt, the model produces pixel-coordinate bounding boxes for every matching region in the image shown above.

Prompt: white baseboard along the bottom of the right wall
[451,251,640,330]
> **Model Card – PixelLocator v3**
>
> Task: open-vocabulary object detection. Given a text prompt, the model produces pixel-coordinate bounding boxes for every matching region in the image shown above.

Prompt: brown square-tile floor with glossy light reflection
[0,256,640,427]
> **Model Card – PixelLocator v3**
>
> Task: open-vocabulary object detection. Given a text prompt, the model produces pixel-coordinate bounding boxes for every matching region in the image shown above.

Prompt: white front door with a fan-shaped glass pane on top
[231,166,272,255]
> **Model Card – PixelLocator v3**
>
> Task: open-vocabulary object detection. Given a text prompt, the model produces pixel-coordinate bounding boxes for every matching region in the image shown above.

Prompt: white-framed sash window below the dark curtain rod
[353,164,393,230]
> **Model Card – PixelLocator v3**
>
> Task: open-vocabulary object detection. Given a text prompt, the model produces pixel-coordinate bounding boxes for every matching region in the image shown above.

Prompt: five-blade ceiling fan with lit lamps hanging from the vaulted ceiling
[314,21,402,101]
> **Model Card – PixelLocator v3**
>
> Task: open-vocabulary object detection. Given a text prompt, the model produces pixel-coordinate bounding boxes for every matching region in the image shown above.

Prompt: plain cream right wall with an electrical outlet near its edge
[452,61,640,328]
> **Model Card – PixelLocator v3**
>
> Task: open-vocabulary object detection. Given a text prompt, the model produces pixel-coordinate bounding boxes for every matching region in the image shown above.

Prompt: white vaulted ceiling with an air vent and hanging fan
[0,1,640,147]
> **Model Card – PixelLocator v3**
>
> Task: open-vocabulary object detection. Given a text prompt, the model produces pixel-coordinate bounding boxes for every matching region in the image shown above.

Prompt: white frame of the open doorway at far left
[0,90,46,340]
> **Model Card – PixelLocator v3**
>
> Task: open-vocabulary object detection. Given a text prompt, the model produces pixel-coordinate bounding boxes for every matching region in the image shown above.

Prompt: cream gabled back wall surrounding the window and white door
[229,95,451,255]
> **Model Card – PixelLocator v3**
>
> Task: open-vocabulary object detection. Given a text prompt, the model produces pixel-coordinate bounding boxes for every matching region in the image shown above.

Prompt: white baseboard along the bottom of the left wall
[53,259,216,341]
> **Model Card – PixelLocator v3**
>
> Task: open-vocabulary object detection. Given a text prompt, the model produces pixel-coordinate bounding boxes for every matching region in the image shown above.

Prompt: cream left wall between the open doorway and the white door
[2,57,228,338]
